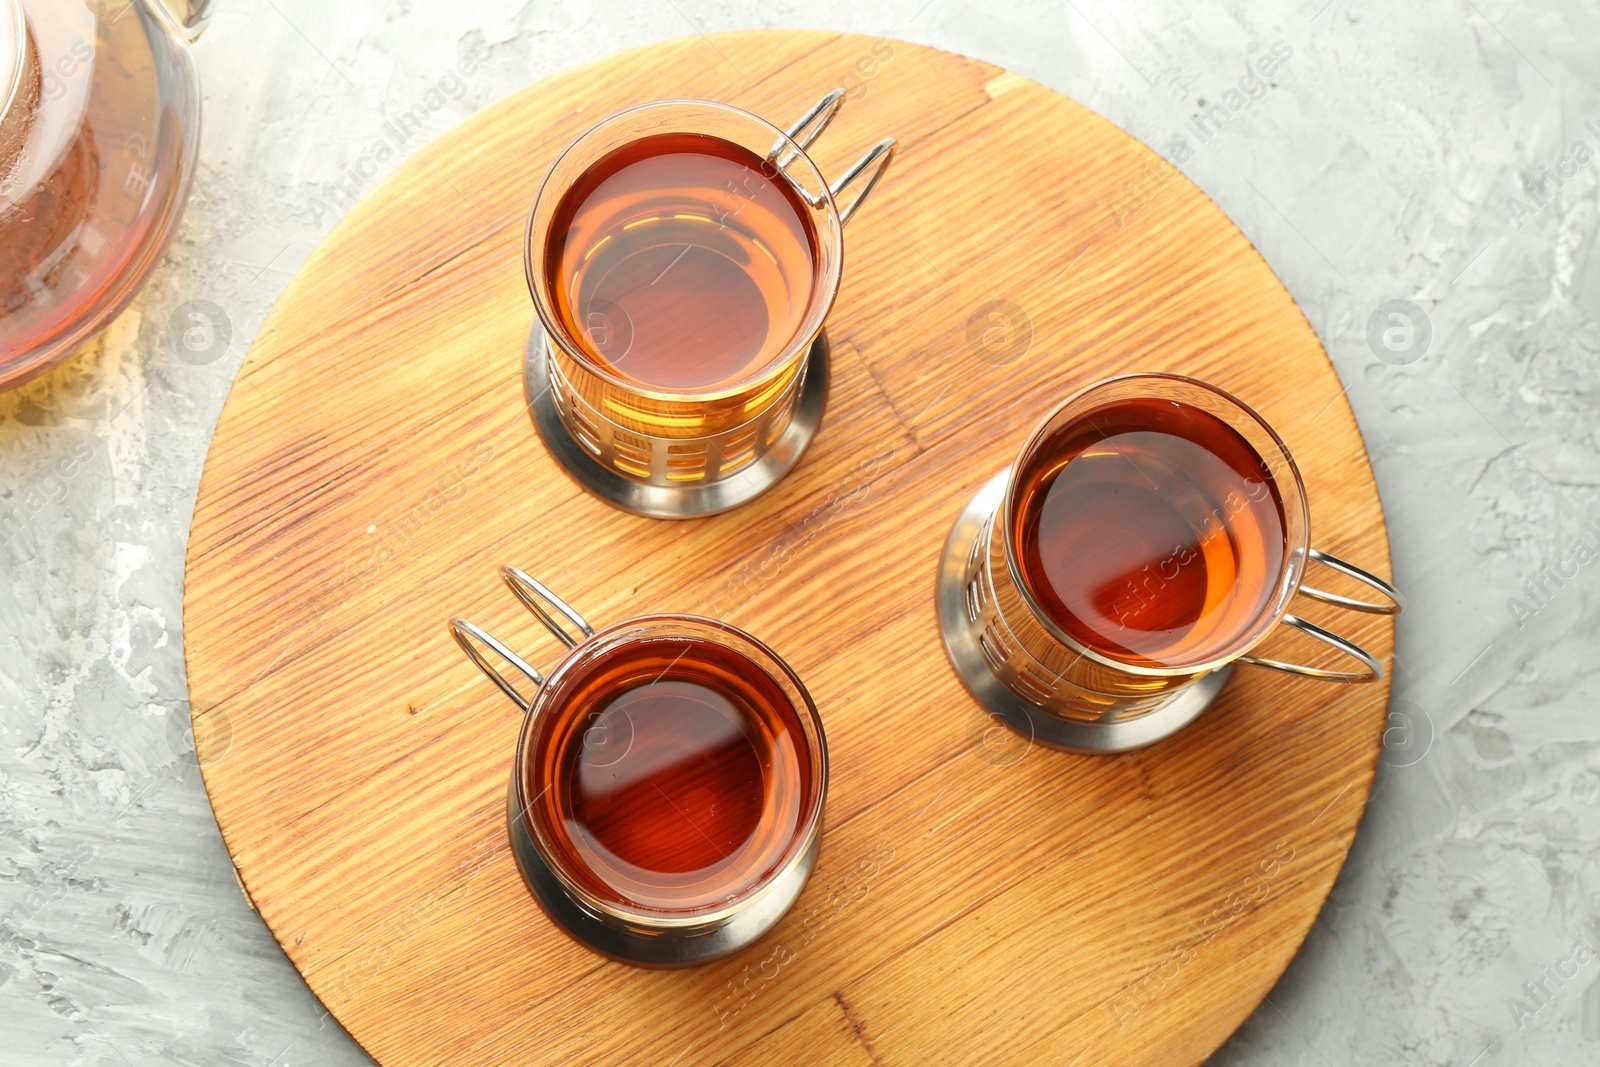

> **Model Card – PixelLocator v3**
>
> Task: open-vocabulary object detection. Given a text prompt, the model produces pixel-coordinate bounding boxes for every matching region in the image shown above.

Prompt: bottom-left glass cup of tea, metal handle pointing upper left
[450,566,827,968]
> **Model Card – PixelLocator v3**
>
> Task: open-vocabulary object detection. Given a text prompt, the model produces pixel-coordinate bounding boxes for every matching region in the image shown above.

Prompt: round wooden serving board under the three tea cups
[184,32,1392,1067]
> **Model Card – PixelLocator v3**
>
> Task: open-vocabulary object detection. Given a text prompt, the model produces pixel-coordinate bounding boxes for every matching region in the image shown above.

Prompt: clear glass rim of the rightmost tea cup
[990,371,1310,678]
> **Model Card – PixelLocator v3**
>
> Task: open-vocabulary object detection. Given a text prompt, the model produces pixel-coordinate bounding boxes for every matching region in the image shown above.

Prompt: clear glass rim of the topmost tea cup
[524,97,845,403]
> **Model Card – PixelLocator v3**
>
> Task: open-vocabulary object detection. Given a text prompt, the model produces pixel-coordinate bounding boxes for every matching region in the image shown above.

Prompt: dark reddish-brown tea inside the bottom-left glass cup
[525,637,814,912]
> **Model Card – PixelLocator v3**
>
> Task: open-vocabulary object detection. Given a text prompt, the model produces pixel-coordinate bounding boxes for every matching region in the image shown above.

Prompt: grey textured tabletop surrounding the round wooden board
[0,0,1600,1067]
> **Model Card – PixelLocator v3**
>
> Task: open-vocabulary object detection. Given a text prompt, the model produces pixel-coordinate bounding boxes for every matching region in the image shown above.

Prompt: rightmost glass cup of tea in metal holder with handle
[938,374,1405,752]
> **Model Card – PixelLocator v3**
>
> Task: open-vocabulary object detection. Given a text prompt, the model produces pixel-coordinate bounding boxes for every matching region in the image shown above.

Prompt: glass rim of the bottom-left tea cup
[512,613,827,929]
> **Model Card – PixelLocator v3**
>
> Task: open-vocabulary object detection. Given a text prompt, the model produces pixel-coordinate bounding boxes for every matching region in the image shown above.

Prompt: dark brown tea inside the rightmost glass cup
[1013,398,1286,667]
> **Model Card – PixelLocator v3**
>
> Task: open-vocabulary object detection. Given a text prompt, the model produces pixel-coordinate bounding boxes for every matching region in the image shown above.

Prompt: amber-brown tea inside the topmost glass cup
[546,133,816,390]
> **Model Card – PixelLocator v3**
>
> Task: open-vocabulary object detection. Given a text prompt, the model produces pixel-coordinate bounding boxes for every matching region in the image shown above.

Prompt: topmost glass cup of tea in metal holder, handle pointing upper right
[525,90,894,518]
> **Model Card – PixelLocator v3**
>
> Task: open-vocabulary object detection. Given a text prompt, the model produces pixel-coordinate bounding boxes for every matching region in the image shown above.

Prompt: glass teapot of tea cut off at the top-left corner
[0,0,211,389]
